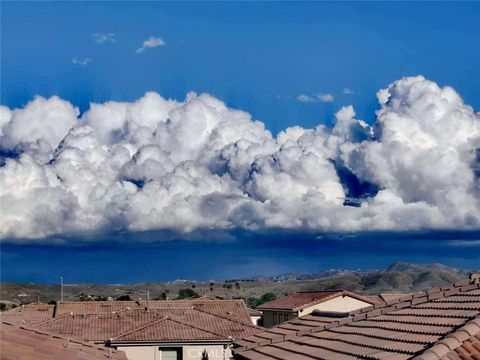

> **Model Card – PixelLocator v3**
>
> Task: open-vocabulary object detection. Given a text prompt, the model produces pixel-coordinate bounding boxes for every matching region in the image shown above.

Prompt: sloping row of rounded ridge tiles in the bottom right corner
[413,317,480,360]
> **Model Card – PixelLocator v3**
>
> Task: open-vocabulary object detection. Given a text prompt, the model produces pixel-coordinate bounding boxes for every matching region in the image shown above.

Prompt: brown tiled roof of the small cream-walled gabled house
[257,290,379,311]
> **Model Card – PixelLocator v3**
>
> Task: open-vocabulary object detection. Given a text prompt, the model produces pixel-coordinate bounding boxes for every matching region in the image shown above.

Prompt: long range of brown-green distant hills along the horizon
[0,262,468,304]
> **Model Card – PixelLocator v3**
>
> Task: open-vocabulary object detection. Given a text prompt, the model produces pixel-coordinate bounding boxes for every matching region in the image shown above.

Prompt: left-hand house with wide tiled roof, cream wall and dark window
[2,298,263,360]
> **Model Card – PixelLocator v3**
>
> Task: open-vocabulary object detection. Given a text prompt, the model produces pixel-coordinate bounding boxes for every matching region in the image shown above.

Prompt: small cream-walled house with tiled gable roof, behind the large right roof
[257,290,380,328]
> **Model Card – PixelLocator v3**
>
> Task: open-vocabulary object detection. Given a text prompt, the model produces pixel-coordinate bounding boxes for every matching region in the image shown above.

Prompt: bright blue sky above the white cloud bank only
[1,2,480,133]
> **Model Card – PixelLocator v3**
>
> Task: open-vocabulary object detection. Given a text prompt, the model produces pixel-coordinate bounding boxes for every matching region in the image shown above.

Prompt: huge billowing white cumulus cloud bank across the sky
[0,76,480,240]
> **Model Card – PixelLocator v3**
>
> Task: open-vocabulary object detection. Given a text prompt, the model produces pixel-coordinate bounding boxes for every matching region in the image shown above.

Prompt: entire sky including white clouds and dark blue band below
[0,1,480,283]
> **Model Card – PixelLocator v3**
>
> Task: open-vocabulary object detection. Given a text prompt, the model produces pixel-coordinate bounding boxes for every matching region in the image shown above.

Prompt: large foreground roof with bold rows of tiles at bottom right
[234,275,480,360]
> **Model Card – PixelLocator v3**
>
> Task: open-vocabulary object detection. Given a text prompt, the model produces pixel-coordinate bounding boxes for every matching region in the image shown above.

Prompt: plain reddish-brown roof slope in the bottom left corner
[0,321,127,360]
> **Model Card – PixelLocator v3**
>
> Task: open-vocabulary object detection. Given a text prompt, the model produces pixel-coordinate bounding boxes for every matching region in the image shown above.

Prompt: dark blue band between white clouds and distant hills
[1,231,480,283]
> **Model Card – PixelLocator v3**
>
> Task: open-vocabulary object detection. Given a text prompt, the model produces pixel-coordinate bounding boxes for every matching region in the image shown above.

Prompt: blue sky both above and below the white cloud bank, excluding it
[0,1,480,282]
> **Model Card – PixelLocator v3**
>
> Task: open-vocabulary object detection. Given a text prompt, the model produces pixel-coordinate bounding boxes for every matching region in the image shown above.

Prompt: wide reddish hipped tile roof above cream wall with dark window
[29,298,263,343]
